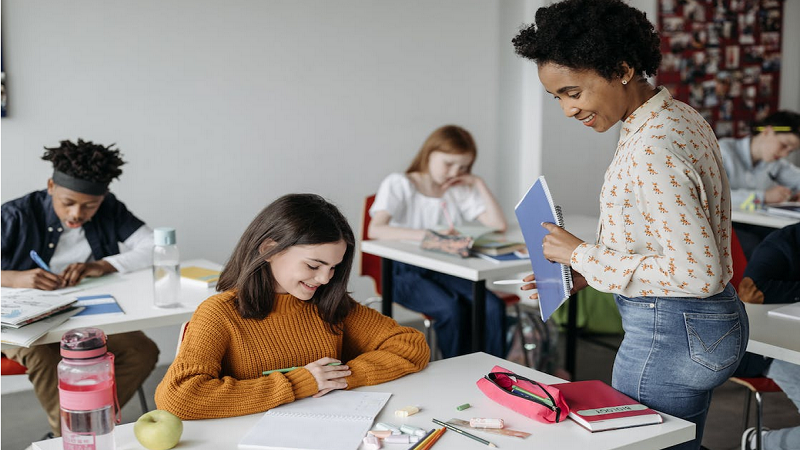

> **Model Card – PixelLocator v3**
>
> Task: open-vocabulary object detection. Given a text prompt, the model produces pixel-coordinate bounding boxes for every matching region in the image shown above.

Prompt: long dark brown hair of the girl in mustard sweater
[217,194,355,331]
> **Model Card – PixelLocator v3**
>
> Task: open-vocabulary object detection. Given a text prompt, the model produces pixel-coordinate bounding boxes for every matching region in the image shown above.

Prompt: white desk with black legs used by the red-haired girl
[361,234,531,351]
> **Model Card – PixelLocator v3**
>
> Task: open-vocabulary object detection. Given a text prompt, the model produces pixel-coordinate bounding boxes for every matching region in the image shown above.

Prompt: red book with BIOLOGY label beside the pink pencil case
[551,380,664,432]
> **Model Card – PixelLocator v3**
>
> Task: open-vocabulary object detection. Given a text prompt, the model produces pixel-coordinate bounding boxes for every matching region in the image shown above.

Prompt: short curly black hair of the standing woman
[512,0,661,80]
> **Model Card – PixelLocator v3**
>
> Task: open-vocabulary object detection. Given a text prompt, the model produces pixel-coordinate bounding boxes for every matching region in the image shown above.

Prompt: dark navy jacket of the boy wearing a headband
[2,190,144,270]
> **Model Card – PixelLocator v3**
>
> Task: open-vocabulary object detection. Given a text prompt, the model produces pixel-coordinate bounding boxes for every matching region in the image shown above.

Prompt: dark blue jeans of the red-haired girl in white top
[392,261,506,358]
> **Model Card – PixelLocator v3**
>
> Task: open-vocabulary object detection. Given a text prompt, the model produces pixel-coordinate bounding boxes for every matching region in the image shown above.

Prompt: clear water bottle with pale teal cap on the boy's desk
[153,227,181,308]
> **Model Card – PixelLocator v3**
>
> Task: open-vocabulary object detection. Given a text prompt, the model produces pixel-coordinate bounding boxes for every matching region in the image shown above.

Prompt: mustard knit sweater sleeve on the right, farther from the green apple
[342,304,430,389]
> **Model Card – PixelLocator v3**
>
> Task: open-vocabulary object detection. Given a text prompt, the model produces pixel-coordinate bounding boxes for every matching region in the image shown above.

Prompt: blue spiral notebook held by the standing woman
[514,176,572,320]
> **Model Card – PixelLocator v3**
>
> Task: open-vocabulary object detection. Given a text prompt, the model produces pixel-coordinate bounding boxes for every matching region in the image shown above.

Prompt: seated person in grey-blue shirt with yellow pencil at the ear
[719,111,800,258]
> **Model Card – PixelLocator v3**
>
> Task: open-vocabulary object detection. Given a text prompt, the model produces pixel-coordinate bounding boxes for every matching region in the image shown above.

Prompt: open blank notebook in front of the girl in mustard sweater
[239,390,392,450]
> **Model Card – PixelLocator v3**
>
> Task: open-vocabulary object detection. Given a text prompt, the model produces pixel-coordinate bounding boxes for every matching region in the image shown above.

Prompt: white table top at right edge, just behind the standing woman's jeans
[745,303,800,364]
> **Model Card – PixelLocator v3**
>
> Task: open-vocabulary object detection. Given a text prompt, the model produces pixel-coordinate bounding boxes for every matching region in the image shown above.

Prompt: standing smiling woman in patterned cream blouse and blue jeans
[513,0,749,449]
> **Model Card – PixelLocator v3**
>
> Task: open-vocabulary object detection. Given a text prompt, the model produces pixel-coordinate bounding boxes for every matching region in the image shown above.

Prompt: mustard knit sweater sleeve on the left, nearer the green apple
[155,294,319,419]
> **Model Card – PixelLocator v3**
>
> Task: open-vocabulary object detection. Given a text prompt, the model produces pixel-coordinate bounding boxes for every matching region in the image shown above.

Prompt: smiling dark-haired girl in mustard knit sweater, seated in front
[156,194,430,419]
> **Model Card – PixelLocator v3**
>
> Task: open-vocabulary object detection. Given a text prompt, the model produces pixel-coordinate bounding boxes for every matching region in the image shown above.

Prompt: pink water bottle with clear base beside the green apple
[58,328,120,450]
